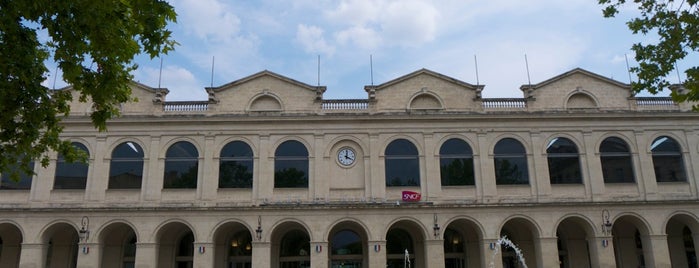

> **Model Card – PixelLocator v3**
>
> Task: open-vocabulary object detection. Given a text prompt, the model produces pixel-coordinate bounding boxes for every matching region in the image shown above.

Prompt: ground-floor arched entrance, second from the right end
[612,215,651,268]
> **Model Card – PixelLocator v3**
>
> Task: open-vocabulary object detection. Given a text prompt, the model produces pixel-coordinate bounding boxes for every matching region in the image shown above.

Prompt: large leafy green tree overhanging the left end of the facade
[0,0,176,179]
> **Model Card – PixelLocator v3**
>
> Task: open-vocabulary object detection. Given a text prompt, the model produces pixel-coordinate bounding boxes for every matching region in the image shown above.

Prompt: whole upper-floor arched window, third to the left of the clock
[163,141,199,189]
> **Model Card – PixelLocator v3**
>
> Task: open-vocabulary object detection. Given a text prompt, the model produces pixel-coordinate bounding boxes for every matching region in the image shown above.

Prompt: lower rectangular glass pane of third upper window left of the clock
[163,160,199,189]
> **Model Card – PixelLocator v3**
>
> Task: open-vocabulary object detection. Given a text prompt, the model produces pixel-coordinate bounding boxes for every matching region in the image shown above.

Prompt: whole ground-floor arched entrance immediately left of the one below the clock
[271,222,311,268]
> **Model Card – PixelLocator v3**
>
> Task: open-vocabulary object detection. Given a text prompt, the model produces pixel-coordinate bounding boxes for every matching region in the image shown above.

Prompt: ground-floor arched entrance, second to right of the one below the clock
[444,219,484,268]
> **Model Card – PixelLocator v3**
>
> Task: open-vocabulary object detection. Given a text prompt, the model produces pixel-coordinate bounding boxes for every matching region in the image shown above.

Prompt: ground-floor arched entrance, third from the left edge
[99,223,137,268]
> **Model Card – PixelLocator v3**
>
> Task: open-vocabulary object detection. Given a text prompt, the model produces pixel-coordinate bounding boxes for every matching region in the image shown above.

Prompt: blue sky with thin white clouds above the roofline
[47,0,689,100]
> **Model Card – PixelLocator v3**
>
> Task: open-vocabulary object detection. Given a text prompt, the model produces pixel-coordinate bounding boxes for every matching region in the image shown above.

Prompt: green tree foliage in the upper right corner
[598,0,699,110]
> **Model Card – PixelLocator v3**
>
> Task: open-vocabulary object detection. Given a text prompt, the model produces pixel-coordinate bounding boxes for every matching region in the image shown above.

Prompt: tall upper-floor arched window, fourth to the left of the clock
[109,141,143,189]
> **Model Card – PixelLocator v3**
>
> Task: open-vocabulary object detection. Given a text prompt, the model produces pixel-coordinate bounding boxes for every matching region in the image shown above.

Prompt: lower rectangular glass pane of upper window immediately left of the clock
[274,159,308,188]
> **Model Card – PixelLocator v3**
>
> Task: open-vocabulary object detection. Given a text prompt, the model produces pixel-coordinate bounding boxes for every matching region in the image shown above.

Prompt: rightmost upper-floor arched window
[650,136,687,182]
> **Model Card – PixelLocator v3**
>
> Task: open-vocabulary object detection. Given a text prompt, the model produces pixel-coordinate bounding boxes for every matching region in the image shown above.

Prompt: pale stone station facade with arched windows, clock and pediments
[0,69,699,268]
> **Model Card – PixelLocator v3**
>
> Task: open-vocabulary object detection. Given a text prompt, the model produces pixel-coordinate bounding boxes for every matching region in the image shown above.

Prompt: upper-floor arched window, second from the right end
[599,137,636,183]
